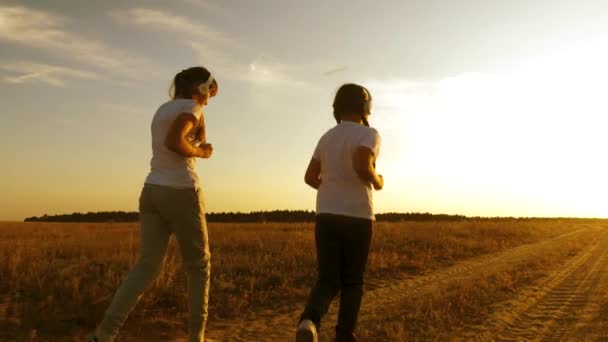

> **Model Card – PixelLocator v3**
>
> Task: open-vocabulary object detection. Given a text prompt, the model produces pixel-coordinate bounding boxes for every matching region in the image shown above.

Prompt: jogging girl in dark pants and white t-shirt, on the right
[296,84,384,342]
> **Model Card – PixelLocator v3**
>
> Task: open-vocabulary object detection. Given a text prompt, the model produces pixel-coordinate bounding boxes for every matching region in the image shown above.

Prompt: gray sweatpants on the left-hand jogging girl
[97,184,211,342]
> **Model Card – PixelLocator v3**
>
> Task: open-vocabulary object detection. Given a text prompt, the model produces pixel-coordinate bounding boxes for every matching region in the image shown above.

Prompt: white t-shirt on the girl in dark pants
[312,121,380,220]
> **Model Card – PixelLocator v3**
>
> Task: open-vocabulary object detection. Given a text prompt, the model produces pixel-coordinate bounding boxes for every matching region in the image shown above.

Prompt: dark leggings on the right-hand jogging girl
[301,214,372,341]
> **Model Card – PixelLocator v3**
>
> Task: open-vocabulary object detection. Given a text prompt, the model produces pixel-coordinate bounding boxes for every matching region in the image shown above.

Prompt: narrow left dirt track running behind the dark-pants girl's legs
[202,227,606,341]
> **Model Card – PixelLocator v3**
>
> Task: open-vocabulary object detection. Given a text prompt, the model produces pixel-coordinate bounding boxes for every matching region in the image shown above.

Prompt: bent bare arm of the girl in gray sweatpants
[165,113,213,158]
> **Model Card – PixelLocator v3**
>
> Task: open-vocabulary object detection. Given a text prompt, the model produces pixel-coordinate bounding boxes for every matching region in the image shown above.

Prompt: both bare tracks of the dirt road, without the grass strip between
[127,226,608,341]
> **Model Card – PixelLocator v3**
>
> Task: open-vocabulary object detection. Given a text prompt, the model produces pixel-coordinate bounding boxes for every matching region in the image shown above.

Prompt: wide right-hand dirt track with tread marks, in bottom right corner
[460,226,608,341]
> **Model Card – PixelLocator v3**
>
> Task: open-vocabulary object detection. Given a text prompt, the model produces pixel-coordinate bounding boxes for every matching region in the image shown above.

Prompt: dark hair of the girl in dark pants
[333,83,372,126]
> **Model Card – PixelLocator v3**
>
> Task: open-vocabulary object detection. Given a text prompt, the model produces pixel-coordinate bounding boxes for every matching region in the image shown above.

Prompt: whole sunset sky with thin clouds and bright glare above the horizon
[0,0,608,220]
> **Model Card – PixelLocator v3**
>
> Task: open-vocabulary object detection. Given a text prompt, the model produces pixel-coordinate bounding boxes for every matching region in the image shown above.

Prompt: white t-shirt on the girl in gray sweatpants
[146,99,201,189]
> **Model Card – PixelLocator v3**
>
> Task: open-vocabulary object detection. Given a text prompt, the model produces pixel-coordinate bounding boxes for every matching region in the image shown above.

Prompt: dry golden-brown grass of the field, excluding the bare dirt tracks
[0,220,606,341]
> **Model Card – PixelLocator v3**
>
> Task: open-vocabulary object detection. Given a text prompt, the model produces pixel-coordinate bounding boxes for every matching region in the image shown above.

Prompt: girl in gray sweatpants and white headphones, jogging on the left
[89,67,218,342]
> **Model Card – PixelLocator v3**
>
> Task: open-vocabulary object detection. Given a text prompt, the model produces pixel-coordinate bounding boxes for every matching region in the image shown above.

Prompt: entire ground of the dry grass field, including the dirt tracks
[0,220,608,341]
